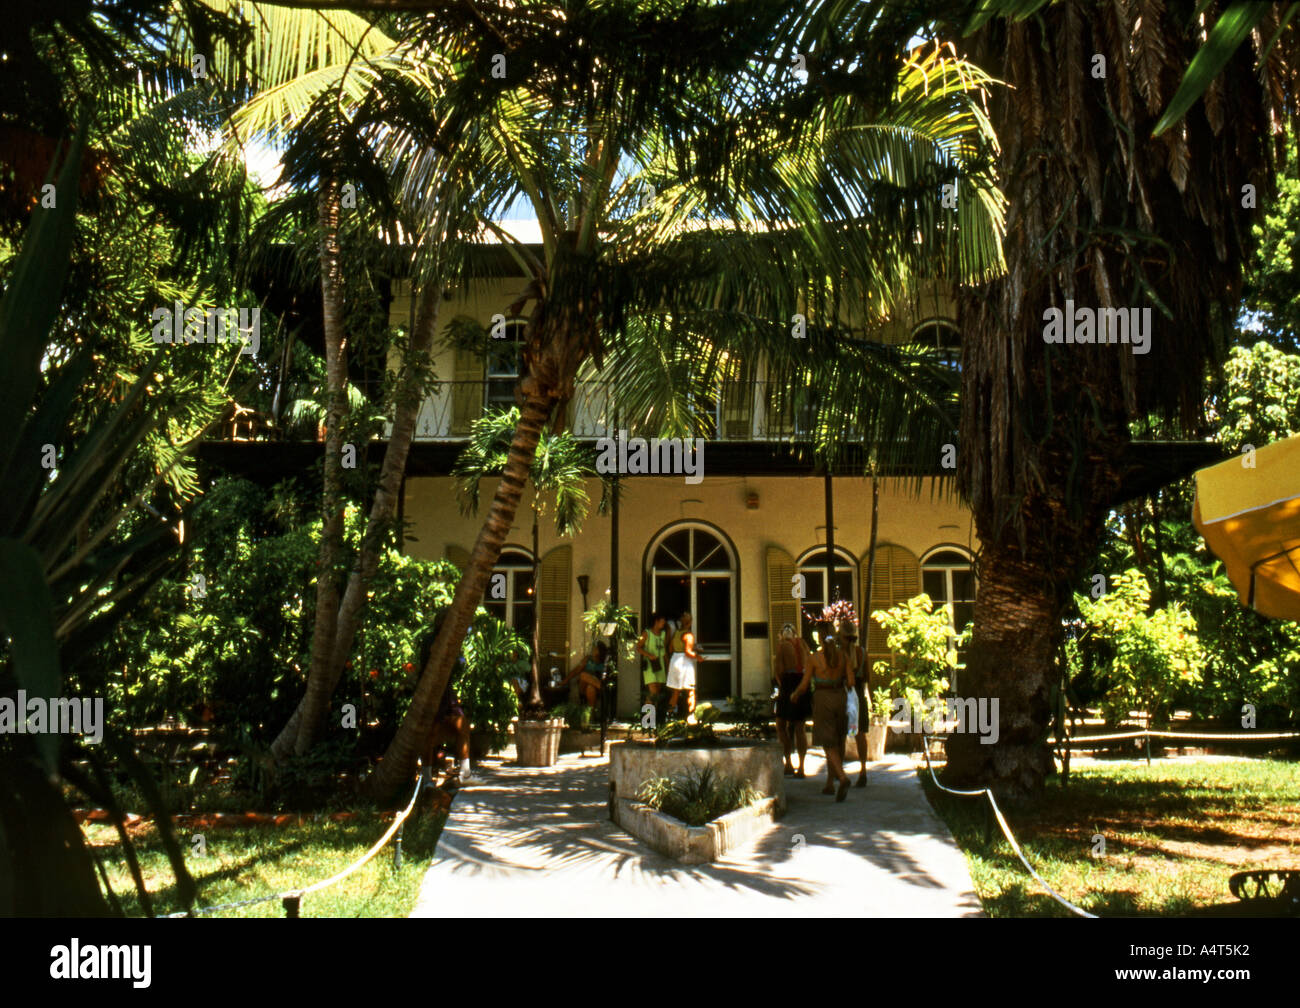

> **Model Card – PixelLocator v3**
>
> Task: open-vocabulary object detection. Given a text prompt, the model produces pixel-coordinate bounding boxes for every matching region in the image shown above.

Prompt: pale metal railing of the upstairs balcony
[385,381,816,441]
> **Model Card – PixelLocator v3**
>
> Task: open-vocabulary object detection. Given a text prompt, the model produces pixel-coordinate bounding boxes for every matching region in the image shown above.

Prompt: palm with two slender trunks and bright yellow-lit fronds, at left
[162,0,470,758]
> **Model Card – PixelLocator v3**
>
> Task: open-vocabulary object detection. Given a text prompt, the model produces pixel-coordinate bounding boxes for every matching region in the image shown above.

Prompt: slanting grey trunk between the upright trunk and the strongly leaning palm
[272,284,443,758]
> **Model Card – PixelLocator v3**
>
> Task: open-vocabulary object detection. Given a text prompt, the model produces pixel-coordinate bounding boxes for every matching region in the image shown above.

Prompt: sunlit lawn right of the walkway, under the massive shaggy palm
[919,758,1300,917]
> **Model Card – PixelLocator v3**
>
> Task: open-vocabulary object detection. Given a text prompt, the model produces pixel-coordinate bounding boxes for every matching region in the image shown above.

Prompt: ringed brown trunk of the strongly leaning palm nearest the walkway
[371,380,558,801]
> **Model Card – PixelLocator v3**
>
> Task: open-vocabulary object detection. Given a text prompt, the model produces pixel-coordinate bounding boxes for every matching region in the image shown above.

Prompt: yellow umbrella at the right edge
[1192,436,1300,619]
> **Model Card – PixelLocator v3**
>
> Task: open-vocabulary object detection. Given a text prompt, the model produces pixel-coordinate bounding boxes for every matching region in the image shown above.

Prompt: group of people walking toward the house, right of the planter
[772,622,867,801]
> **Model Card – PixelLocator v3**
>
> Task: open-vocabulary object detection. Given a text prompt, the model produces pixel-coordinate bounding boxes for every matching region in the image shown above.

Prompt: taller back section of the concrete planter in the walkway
[610,739,785,829]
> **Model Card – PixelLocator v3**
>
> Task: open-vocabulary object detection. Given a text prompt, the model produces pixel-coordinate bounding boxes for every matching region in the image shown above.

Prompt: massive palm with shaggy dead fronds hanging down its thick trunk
[946,0,1296,799]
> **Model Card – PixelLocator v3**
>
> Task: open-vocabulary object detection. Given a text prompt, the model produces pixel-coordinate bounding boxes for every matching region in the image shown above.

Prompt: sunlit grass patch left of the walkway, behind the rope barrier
[82,802,445,917]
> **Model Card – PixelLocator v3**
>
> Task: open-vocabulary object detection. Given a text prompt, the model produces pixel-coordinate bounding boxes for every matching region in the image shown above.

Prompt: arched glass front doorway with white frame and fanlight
[645,522,738,700]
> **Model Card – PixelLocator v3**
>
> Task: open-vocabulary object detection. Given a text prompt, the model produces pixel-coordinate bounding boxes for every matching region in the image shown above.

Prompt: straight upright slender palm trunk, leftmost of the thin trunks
[292,178,347,752]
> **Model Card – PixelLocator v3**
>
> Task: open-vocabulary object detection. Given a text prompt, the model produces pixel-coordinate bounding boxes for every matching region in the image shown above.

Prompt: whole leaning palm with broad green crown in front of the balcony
[373,3,1000,796]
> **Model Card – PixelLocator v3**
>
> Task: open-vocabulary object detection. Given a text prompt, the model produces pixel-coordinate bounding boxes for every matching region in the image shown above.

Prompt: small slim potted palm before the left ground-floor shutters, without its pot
[452,408,614,717]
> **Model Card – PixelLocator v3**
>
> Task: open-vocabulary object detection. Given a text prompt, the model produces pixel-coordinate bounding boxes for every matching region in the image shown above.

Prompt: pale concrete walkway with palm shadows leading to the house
[411,753,982,917]
